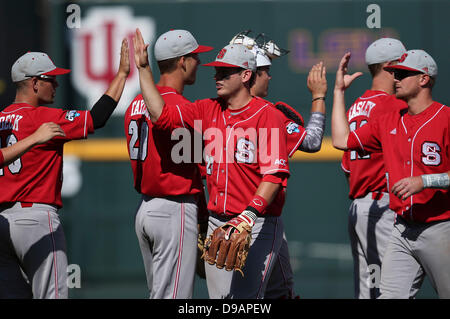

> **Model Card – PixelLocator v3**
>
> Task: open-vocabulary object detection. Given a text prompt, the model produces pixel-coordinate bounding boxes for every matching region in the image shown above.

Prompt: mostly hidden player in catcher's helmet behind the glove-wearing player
[230,31,327,299]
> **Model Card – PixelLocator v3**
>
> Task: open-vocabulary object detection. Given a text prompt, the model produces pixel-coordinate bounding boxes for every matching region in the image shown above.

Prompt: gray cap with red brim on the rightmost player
[384,50,437,77]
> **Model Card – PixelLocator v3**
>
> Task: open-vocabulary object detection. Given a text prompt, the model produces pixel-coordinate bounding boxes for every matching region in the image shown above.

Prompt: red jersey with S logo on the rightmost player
[347,102,450,222]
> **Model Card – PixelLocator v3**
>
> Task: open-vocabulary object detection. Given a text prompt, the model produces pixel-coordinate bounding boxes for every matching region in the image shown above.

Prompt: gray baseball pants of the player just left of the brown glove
[135,195,198,299]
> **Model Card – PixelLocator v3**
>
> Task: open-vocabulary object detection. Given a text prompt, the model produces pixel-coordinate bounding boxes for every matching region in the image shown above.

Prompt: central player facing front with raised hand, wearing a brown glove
[134,30,289,298]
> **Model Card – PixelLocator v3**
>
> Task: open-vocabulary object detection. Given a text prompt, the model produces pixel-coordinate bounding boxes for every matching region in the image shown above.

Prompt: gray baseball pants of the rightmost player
[380,216,450,299]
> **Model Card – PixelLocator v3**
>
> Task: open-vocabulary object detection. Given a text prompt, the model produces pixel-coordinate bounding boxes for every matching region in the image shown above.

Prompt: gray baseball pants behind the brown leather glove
[205,215,284,299]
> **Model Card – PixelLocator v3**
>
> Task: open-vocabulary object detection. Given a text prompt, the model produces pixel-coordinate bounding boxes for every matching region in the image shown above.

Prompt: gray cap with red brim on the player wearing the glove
[203,44,256,71]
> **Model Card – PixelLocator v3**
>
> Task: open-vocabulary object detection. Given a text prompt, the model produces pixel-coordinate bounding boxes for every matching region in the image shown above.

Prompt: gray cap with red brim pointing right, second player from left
[154,30,213,61]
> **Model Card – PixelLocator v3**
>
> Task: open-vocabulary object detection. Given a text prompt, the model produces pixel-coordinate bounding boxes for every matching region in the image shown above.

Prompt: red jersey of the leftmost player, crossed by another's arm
[0,103,94,207]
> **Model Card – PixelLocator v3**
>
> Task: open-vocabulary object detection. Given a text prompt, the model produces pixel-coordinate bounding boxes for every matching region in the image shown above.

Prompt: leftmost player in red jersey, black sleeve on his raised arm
[0,40,130,298]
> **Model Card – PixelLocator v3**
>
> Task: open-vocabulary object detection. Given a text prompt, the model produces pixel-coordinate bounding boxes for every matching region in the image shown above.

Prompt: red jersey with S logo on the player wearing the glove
[155,98,289,216]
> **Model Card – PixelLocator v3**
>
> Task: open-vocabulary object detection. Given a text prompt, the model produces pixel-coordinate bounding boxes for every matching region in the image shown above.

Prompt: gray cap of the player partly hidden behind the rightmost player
[366,38,406,65]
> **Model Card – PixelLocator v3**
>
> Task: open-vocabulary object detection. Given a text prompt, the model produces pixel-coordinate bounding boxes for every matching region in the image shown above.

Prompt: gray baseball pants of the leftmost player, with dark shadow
[0,203,68,299]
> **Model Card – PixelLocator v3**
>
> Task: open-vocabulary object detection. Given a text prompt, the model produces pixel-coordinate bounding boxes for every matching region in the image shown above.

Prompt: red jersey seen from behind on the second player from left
[125,86,203,197]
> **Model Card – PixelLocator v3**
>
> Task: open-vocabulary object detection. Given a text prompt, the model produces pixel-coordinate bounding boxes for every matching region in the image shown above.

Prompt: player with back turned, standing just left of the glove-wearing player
[125,30,212,299]
